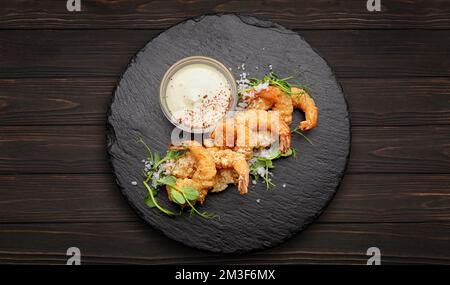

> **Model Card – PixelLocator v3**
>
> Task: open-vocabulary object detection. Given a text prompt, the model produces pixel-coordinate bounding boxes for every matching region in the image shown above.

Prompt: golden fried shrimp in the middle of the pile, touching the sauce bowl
[211,109,291,152]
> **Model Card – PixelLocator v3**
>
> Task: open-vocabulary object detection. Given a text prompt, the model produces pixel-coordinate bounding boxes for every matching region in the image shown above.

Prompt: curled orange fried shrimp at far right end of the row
[291,87,318,131]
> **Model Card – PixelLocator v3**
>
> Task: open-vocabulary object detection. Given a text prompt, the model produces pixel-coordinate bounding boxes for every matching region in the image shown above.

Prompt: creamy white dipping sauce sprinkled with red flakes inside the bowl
[166,63,232,129]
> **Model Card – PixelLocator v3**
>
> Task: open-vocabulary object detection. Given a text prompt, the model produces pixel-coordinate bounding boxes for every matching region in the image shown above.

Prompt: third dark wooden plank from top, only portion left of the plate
[0,77,112,125]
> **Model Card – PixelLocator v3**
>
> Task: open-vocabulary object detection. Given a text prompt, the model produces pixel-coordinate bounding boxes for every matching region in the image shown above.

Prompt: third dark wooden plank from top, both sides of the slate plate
[0,77,450,126]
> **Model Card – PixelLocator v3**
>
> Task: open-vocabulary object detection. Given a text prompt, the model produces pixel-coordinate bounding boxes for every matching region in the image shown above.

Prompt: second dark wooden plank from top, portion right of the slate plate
[299,30,450,78]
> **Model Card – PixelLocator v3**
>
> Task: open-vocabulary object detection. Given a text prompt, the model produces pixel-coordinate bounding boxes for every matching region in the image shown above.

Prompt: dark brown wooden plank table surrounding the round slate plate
[0,0,450,264]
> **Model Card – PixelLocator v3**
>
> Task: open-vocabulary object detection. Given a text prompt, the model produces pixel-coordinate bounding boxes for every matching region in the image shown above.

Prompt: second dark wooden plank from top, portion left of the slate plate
[0,30,159,78]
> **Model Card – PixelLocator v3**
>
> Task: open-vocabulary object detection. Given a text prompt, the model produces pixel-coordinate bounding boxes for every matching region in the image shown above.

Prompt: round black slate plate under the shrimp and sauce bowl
[108,15,350,253]
